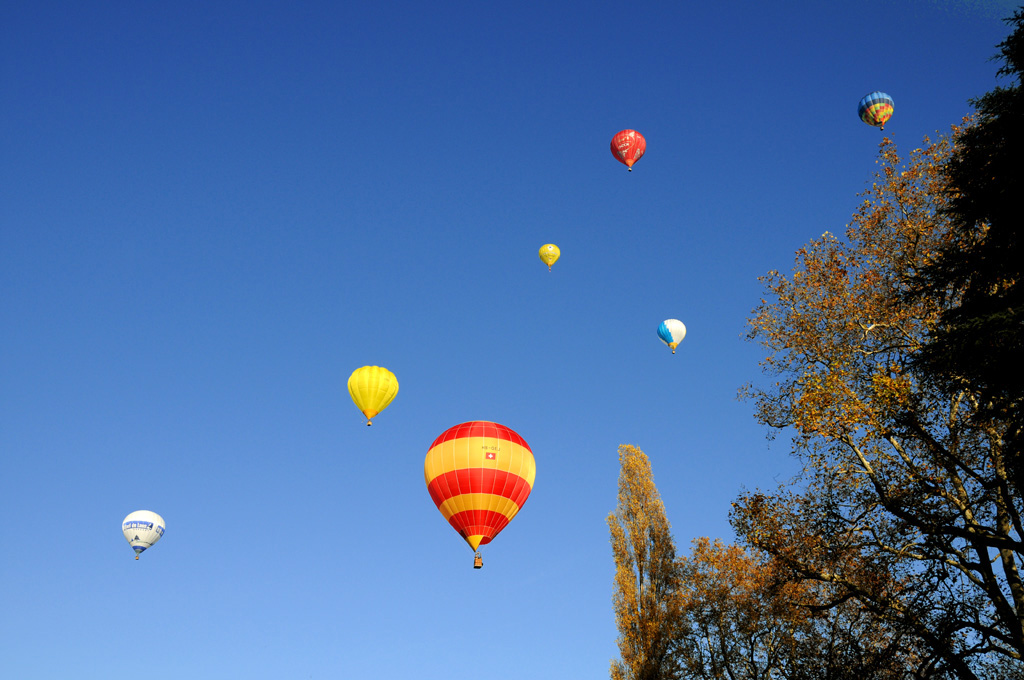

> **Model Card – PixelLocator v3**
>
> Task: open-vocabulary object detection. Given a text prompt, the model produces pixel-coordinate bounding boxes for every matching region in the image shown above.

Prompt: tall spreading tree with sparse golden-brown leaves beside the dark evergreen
[732,127,1024,680]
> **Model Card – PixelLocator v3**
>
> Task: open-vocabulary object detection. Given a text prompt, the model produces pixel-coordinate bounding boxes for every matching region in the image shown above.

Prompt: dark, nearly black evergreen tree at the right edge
[911,8,1024,495]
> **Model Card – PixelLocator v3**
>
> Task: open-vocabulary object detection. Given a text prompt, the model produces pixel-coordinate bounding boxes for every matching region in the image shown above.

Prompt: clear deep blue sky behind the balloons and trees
[0,0,1014,680]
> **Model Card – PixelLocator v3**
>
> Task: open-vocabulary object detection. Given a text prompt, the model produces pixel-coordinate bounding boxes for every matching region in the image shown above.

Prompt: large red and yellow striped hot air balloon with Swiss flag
[423,420,537,568]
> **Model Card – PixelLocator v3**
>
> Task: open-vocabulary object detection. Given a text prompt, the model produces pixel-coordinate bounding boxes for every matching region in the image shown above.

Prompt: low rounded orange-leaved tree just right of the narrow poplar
[680,539,915,680]
